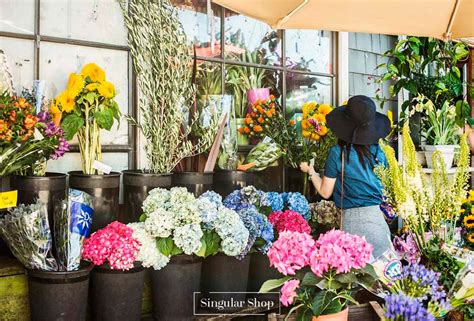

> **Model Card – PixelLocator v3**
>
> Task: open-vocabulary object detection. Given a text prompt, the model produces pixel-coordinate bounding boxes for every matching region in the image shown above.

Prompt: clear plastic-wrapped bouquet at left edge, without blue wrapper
[0,202,58,271]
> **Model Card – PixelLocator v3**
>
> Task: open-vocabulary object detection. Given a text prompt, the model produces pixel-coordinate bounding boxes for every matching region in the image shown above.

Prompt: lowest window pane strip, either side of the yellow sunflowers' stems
[47,153,128,173]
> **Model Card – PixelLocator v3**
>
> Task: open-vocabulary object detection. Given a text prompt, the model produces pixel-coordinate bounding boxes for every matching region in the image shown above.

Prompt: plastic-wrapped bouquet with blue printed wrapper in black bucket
[54,189,94,271]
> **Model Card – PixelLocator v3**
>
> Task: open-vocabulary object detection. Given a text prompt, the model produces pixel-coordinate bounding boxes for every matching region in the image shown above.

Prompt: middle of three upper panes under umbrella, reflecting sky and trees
[224,10,281,66]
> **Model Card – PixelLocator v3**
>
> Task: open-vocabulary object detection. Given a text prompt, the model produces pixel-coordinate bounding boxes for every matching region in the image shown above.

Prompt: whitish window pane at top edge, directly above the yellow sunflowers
[40,0,127,45]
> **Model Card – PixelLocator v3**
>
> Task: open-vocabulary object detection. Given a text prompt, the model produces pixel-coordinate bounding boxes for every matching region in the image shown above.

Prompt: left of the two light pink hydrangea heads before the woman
[267,231,314,275]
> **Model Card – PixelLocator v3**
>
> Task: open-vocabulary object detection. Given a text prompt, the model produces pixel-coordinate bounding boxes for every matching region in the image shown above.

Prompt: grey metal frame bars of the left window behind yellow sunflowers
[0,0,137,168]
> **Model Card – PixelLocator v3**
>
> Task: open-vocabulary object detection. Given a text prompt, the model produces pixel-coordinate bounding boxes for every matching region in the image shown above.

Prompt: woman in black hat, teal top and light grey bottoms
[300,96,392,258]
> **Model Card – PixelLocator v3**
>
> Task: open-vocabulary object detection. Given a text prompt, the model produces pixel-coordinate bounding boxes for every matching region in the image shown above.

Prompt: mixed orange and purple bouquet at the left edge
[0,91,69,176]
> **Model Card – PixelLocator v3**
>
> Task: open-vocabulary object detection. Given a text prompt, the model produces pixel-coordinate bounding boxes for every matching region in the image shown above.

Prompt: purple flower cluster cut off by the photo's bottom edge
[385,293,435,321]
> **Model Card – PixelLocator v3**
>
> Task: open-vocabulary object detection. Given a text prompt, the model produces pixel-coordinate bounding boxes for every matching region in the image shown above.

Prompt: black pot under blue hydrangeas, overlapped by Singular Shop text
[201,253,250,313]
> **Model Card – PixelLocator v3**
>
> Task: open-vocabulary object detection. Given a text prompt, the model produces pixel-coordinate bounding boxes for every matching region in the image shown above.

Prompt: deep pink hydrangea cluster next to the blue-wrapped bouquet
[82,221,140,270]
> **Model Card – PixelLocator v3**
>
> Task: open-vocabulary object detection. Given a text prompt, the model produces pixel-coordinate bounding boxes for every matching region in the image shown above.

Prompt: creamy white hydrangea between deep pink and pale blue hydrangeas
[128,223,170,270]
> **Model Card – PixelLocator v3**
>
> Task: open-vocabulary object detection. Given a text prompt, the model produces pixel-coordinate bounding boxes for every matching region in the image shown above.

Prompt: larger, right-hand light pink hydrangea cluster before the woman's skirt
[310,230,373,276]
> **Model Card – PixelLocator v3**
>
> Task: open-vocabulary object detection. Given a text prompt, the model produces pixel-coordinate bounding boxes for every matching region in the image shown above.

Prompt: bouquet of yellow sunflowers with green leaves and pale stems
[55,63,120,174]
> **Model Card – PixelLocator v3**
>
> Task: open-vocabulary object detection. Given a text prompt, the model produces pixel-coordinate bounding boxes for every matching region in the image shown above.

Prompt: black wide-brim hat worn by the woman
[326,95,391,145]
